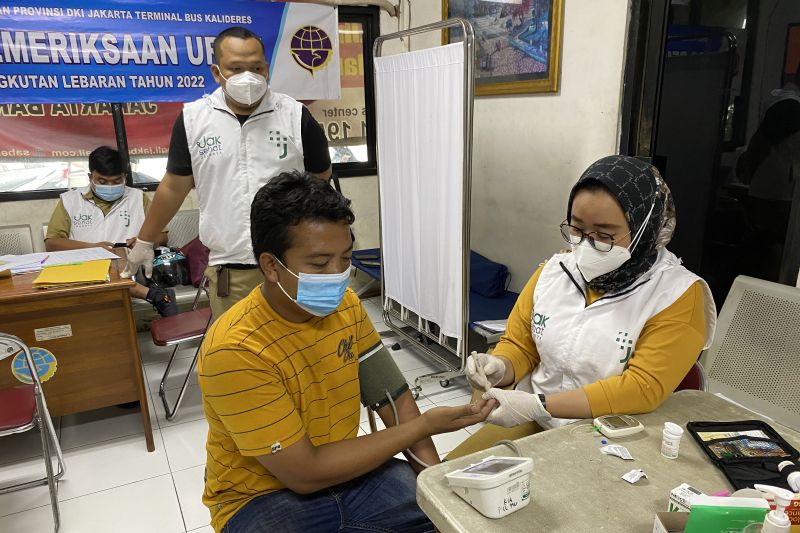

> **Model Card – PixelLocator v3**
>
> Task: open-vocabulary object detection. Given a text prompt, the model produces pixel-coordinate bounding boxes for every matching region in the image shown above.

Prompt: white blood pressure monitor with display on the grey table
[445,455,533,518]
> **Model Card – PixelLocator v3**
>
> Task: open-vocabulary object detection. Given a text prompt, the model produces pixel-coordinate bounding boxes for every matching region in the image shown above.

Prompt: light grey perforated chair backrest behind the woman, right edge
[700,276,800,430]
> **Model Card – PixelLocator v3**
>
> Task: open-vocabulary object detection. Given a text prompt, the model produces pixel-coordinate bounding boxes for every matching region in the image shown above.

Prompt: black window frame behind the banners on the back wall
[0,6,380,203]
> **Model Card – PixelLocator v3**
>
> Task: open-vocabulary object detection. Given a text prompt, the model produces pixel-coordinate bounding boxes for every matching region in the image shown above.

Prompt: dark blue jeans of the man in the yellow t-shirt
[222,459,433,533]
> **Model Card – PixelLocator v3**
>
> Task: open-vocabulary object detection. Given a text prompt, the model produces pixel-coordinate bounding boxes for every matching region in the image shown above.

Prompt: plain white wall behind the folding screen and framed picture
[356,0,628,290]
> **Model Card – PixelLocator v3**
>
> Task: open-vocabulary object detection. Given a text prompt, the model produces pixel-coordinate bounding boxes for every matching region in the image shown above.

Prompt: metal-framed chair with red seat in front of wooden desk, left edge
[0,333,66,531]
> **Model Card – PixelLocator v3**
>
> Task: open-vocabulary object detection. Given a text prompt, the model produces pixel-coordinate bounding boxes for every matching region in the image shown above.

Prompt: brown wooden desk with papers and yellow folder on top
[0,261,155,451]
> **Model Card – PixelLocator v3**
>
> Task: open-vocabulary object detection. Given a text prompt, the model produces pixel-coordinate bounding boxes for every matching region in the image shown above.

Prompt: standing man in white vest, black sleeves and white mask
[123,27,331,317]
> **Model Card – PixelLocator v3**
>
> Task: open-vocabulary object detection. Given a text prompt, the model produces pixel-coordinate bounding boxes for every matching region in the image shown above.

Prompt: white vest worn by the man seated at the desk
[61,187,144,243]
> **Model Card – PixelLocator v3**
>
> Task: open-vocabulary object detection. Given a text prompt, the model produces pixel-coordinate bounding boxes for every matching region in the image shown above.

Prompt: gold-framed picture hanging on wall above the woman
[442,0,564,96]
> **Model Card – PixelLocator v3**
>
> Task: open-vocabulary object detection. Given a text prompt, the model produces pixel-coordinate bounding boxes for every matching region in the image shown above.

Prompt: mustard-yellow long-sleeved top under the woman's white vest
[492,265,706,417]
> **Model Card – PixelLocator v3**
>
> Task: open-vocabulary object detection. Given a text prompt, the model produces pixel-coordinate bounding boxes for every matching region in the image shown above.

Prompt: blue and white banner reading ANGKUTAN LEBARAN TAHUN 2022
[0,0,340,104]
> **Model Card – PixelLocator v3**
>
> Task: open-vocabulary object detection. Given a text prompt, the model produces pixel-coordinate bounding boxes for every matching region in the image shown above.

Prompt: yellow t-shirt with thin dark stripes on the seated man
[198,285,381,531]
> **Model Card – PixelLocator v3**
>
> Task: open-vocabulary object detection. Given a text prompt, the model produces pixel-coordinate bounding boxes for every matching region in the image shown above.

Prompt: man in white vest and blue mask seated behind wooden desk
[44,146,178,316]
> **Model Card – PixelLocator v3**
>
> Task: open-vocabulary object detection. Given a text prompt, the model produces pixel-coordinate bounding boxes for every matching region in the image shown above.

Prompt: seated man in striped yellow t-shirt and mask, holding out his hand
[198,172,495,533]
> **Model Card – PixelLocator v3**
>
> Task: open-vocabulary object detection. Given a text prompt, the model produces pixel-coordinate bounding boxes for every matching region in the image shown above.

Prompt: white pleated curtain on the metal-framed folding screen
[375,43,464,339]
